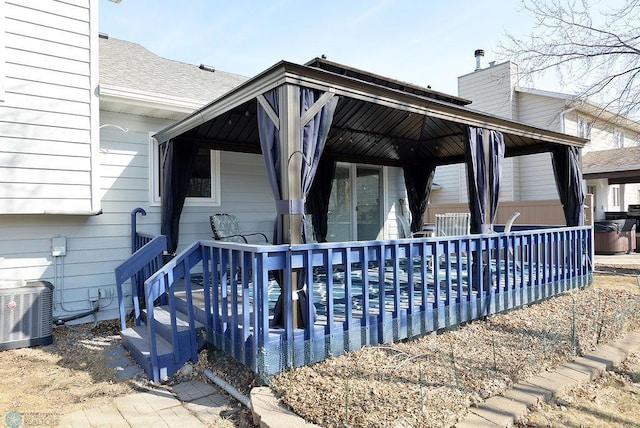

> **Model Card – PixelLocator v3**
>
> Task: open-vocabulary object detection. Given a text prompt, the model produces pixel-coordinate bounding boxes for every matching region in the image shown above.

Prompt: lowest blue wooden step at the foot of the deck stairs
[120,325,182,380]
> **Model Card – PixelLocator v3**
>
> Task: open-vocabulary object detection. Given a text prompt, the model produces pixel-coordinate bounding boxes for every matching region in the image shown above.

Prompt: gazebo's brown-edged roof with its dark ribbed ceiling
[154,58,587,166]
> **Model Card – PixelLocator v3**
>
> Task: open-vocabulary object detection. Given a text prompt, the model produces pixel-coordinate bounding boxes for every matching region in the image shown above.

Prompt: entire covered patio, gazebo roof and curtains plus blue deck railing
[122,58,592,382]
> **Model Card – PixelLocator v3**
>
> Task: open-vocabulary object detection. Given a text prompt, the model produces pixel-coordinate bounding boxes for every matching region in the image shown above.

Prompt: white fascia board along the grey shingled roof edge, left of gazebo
[100,84,207,113]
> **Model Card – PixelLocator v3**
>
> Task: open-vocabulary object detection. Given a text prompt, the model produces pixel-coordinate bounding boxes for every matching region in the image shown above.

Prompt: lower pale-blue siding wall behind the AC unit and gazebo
[0,106,406,319]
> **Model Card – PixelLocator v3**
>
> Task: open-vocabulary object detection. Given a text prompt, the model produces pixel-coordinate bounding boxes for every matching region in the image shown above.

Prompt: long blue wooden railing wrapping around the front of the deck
[145,227,593,378]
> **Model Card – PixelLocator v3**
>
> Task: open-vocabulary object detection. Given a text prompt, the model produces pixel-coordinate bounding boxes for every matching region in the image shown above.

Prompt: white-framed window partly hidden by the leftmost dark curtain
[149,138,220,206]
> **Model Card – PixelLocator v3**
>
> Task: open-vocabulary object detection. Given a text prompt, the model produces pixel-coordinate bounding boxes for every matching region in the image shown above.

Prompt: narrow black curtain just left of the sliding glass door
[307,156,336,242]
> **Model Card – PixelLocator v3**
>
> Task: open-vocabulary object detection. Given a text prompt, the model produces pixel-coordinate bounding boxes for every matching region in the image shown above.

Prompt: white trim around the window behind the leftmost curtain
[149,132,221,207]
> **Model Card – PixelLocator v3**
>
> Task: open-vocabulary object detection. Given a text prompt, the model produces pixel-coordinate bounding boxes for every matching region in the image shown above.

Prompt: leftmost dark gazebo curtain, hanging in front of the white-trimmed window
[160,140,198,254]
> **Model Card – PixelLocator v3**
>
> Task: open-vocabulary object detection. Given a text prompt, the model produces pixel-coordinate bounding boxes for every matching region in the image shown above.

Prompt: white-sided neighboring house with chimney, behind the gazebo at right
[431,55,640,220]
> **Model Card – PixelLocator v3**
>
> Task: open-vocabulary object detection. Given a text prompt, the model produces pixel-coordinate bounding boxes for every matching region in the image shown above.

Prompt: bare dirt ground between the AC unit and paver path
[0,320,253,428]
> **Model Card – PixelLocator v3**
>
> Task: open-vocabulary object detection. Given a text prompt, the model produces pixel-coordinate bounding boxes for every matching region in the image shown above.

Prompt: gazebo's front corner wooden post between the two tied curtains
[279,84,302,328]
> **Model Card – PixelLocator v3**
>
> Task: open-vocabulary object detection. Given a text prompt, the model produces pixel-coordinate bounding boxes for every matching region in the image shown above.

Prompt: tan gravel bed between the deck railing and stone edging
[250,280,640,427]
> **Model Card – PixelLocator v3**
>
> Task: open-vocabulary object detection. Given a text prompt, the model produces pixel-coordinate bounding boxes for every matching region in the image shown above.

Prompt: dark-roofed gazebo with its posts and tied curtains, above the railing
[154,58,587,250]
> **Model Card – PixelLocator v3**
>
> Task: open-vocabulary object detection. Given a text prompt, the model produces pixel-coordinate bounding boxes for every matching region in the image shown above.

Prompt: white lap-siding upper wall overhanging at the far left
[0,0,100,214]
